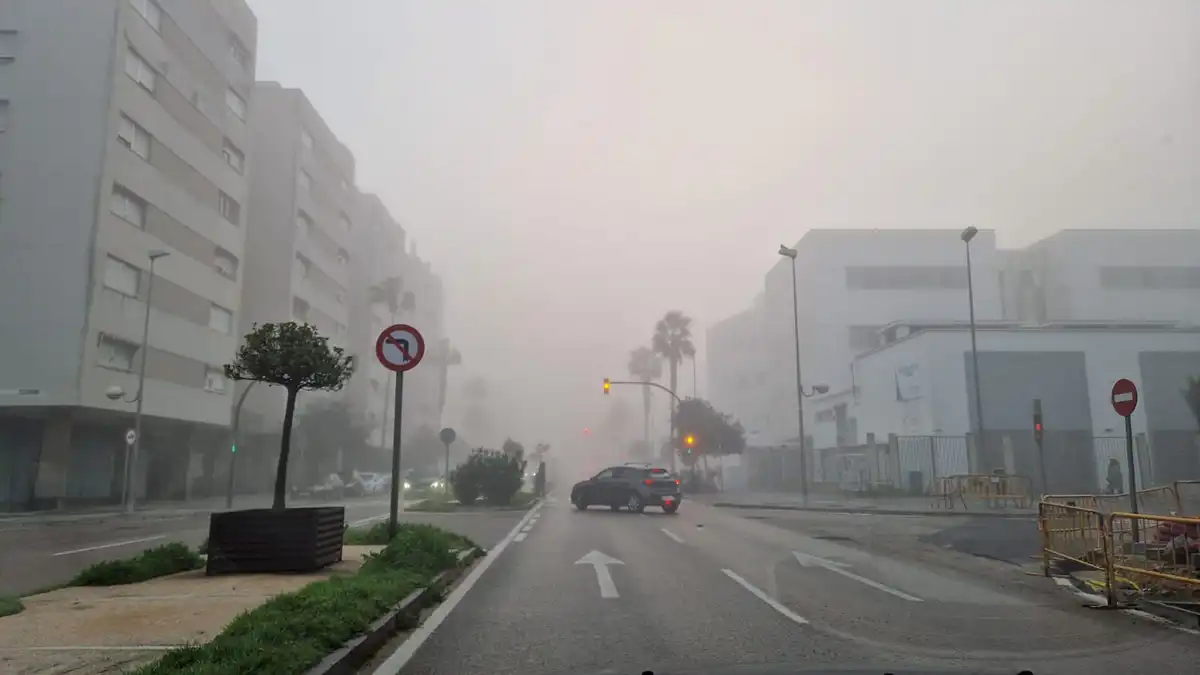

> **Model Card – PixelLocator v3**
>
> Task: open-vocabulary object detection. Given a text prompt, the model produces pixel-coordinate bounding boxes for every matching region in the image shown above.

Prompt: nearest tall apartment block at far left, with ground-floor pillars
[0,0,257,510]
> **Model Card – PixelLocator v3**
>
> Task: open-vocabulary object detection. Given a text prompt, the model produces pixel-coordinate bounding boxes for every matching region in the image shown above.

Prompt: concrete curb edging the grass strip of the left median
[306,548,485,675]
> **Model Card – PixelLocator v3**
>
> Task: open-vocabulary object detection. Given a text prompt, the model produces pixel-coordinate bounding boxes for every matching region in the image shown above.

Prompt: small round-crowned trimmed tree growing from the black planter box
[224,321,354,509]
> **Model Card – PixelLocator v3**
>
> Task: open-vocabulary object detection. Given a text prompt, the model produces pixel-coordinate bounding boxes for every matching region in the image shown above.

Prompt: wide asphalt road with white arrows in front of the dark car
[376,498,1200,675]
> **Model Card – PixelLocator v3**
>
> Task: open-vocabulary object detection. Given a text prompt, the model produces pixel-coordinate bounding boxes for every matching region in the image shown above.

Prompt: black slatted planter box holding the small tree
[205,507,346,577]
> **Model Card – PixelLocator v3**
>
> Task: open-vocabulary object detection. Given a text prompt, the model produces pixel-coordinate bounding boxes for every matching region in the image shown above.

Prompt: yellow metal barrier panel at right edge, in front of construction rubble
[1108,512,1200,596]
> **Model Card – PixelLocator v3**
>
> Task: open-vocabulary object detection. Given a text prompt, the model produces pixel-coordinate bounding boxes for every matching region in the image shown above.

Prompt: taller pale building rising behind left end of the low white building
[763,229,1002,441]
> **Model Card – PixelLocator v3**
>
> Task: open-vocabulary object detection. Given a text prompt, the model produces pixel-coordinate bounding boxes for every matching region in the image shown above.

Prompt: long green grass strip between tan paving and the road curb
[133,524,474,675]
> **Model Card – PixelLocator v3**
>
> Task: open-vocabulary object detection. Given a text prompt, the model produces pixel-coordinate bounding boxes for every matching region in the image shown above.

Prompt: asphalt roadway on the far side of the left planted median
[0,498,522,595]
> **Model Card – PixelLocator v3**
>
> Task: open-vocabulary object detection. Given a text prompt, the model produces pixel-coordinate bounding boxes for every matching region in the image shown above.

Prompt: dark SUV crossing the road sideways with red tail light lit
[571,465,683,513]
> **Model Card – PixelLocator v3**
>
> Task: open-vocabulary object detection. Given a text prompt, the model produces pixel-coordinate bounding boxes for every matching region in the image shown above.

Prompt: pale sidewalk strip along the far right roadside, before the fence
[689,491,1038,518]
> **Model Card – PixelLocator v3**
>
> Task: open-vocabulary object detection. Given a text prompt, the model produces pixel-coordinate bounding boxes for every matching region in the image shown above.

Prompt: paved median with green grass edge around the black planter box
[0,516,481,675]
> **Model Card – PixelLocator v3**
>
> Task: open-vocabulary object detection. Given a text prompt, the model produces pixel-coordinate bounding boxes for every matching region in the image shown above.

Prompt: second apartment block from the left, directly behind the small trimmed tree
[239,82,361,447]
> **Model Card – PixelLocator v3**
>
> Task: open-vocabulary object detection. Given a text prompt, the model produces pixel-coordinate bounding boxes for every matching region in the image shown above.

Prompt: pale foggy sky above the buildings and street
[250,0,1200,447]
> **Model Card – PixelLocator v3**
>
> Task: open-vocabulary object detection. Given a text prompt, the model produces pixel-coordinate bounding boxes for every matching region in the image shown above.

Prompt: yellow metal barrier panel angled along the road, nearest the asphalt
[1038,501,1116,605]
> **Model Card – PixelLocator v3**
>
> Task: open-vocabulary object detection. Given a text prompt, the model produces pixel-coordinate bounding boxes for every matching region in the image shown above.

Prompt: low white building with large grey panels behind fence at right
[811,322,1200,492]
